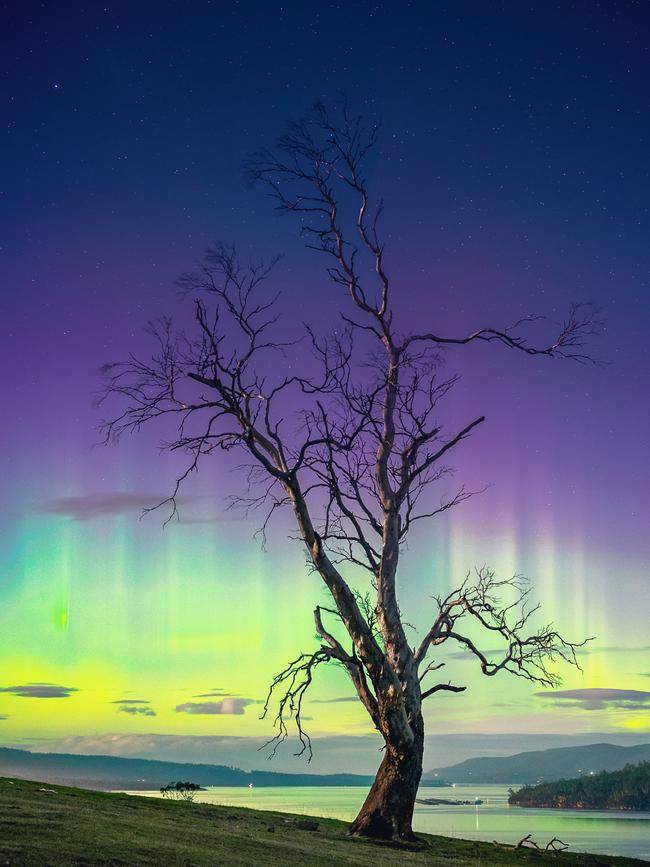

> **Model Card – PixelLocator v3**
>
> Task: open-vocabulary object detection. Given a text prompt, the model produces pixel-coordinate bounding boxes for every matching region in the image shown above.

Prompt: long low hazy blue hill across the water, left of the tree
[0,748,373,790]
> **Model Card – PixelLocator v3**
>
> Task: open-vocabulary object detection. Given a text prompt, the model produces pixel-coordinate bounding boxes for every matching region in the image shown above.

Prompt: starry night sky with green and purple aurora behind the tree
[0,0,650,770]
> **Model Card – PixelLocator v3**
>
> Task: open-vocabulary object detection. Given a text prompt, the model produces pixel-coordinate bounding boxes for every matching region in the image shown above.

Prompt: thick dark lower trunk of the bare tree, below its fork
[350,717,424,841]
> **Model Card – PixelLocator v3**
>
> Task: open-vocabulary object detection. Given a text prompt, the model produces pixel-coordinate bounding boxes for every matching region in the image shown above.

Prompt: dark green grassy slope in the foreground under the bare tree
[0,778,646,867]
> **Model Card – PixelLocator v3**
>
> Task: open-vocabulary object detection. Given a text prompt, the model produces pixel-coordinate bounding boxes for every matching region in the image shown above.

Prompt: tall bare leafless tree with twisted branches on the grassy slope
[97,104,595,840]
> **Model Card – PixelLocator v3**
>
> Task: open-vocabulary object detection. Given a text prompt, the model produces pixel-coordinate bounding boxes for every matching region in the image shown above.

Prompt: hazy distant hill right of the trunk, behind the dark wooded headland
[423,744,650,785]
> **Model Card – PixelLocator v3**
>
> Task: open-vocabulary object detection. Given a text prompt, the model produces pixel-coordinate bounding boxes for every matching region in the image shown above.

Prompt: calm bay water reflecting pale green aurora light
[134,785,650,860]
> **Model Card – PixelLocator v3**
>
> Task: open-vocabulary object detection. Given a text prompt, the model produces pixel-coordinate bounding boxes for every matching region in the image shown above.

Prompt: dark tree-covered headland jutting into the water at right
[509,762,650,810]
